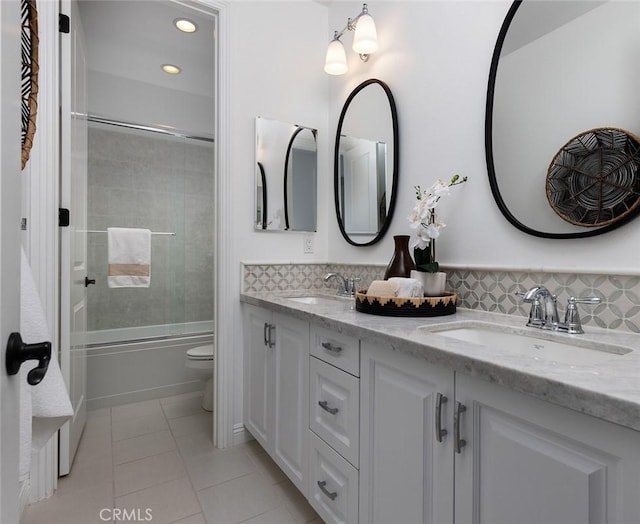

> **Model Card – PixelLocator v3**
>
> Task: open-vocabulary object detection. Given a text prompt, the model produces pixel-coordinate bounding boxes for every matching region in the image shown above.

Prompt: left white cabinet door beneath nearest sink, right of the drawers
[360,342,456,524]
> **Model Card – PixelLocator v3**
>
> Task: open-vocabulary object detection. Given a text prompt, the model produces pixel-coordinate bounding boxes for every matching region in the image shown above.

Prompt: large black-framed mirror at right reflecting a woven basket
[485,0,640,239]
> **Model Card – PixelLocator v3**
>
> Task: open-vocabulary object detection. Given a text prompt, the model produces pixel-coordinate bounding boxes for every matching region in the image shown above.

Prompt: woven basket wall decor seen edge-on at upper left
[20,0,40,169]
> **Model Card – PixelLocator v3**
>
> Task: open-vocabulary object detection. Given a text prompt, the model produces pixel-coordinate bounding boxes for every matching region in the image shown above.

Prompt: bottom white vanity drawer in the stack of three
[307,431,358,523]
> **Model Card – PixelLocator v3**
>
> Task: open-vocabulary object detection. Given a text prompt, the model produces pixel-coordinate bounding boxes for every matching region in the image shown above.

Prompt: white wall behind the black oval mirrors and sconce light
[327,0,640,273]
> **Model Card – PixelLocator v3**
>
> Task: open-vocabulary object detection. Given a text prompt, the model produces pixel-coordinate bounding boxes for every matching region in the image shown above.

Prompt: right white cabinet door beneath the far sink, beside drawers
[273,313,309,493]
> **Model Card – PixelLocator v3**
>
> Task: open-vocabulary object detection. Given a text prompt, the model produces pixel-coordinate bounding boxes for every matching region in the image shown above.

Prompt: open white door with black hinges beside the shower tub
[59,0,87,475]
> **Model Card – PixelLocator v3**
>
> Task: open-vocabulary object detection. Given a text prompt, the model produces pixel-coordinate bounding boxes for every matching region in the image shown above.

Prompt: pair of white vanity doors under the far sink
[243,304,309,493]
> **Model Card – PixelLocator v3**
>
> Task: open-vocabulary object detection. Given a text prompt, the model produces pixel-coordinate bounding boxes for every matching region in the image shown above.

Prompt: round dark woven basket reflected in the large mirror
[546,128,640,227]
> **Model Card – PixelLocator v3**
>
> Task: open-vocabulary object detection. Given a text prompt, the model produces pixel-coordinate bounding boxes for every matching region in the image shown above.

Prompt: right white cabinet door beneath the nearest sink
[455,375,640,524]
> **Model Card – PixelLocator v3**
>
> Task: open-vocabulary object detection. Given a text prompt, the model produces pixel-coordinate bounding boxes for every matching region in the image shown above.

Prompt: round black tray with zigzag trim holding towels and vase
[356,289,457,317]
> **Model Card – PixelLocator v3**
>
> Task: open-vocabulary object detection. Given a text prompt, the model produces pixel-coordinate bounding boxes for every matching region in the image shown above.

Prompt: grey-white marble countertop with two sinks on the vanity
[240,291,640,431]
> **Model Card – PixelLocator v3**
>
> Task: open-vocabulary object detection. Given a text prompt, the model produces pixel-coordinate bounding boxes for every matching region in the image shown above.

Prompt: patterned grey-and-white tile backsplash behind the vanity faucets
[242,263,640,333]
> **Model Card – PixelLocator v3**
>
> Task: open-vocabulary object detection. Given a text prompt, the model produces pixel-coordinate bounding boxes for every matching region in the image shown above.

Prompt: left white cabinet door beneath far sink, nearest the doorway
[243,304,273,450]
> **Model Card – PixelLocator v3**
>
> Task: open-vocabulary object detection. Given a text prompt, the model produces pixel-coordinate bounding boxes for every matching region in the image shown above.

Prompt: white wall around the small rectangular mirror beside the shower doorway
[226,1,330,438]
